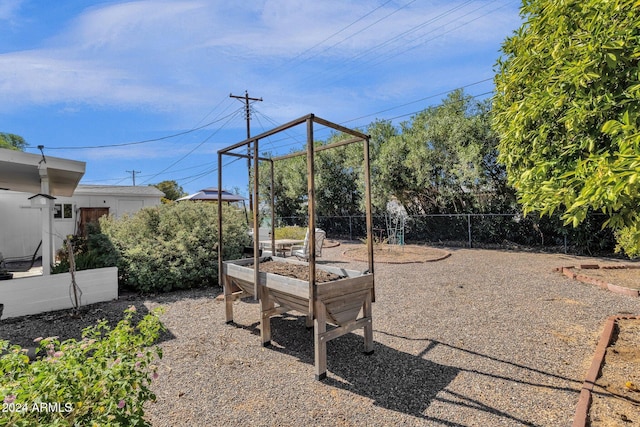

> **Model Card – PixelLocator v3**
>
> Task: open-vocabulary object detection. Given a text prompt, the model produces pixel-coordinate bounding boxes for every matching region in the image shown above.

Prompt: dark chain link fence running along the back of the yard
[276,213,615,255]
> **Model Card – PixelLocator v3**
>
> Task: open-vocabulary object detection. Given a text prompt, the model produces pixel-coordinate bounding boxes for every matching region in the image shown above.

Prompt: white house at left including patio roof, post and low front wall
[0,149,132,318]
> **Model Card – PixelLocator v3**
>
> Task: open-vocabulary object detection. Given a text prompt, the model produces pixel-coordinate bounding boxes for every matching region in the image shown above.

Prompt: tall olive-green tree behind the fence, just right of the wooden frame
[374,90,504,214]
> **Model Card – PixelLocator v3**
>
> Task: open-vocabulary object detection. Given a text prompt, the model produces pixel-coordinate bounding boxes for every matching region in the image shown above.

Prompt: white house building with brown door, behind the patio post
[0,185,164,259]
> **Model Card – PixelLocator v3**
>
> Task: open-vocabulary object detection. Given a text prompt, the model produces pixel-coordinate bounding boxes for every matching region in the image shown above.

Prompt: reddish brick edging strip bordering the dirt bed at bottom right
[572,315,640,427]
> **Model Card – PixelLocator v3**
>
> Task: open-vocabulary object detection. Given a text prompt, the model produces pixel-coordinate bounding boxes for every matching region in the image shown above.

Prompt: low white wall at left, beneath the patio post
[0,267,118,319]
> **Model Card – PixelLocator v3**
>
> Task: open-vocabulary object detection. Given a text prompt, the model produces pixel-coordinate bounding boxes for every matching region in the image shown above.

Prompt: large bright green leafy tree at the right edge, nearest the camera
[493,0,640,256]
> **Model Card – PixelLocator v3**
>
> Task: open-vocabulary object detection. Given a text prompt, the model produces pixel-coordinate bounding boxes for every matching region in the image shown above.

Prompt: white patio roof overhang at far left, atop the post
[0,148,86,197]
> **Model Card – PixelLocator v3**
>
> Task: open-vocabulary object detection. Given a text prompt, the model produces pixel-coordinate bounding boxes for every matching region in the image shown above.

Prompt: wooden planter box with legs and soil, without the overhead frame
[222,257,373,379]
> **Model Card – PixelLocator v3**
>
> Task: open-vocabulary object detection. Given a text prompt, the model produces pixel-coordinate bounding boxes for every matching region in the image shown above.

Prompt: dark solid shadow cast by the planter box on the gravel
[264,315,460,425]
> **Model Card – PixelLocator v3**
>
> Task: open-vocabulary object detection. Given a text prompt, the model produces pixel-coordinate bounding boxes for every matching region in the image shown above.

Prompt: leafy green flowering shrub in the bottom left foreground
[0,306,163,426]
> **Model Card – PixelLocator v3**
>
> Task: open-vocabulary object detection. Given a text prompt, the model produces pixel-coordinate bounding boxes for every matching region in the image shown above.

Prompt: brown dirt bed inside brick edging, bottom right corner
[589,319,640,427]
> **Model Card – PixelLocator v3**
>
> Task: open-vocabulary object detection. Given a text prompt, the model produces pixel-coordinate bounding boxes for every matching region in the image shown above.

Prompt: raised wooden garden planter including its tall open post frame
[218,114,375,380]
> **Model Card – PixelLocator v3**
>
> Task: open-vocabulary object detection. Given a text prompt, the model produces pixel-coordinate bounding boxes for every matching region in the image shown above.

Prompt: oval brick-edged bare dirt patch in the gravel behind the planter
[343,245,451,264]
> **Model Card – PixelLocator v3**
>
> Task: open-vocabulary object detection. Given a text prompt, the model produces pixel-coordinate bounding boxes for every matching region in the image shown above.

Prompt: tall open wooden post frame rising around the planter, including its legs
[218,114,375,379]
